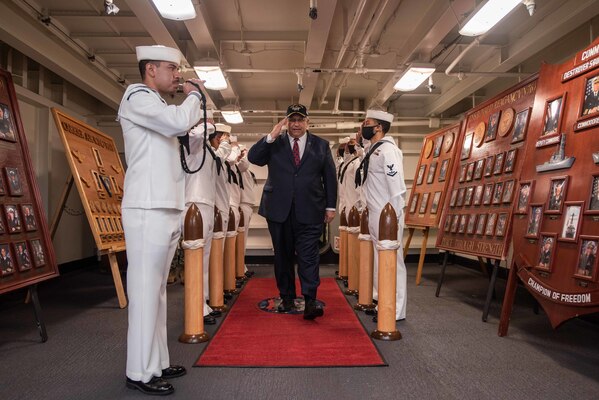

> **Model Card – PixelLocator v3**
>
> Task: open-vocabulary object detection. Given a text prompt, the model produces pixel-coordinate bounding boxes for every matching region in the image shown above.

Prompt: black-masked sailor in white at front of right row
[355,110,407,321]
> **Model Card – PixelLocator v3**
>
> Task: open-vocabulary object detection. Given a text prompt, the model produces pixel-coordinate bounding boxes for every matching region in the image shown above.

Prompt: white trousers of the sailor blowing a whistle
[122,208,181,382]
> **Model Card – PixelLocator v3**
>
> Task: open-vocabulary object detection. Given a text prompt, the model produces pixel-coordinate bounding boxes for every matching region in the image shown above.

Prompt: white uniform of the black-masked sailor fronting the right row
[363,136,408,320]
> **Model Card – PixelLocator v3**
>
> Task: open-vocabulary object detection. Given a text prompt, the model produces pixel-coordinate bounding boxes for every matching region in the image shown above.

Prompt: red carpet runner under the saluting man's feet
[196,278,386,367]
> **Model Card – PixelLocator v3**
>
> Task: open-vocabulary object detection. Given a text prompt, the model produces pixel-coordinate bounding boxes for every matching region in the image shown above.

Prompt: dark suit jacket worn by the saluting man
[248,132,337,224]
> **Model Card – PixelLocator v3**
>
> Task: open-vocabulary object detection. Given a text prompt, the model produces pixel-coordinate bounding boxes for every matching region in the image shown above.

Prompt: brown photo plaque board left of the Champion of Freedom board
[437,75,537,260]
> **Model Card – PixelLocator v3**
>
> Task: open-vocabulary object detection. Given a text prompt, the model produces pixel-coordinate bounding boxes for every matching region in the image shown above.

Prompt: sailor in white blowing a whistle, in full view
[118,46,201,395]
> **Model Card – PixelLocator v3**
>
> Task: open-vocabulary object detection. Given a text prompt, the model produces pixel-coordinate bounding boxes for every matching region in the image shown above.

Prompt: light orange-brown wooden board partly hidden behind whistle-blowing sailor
[52,108,125,252]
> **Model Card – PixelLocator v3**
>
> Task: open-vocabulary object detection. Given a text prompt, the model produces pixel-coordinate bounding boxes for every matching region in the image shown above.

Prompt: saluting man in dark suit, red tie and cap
[248,104,337,319]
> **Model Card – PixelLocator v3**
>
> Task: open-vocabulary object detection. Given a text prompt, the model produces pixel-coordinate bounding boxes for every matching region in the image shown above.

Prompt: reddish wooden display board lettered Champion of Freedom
[499,39,599,336]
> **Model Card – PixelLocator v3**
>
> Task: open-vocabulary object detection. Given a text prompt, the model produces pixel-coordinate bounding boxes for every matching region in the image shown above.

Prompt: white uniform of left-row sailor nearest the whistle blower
[181,123,220,316]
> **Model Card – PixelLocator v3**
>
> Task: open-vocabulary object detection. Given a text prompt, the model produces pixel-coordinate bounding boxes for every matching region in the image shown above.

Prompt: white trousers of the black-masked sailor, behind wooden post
[368,211,408,320]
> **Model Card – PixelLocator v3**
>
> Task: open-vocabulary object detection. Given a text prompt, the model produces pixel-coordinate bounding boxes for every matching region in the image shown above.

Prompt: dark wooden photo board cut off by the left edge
[0,70,58,294]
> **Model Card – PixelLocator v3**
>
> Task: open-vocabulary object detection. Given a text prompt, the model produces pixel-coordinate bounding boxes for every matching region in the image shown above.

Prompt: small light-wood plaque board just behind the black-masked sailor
[405,124,460,227]
